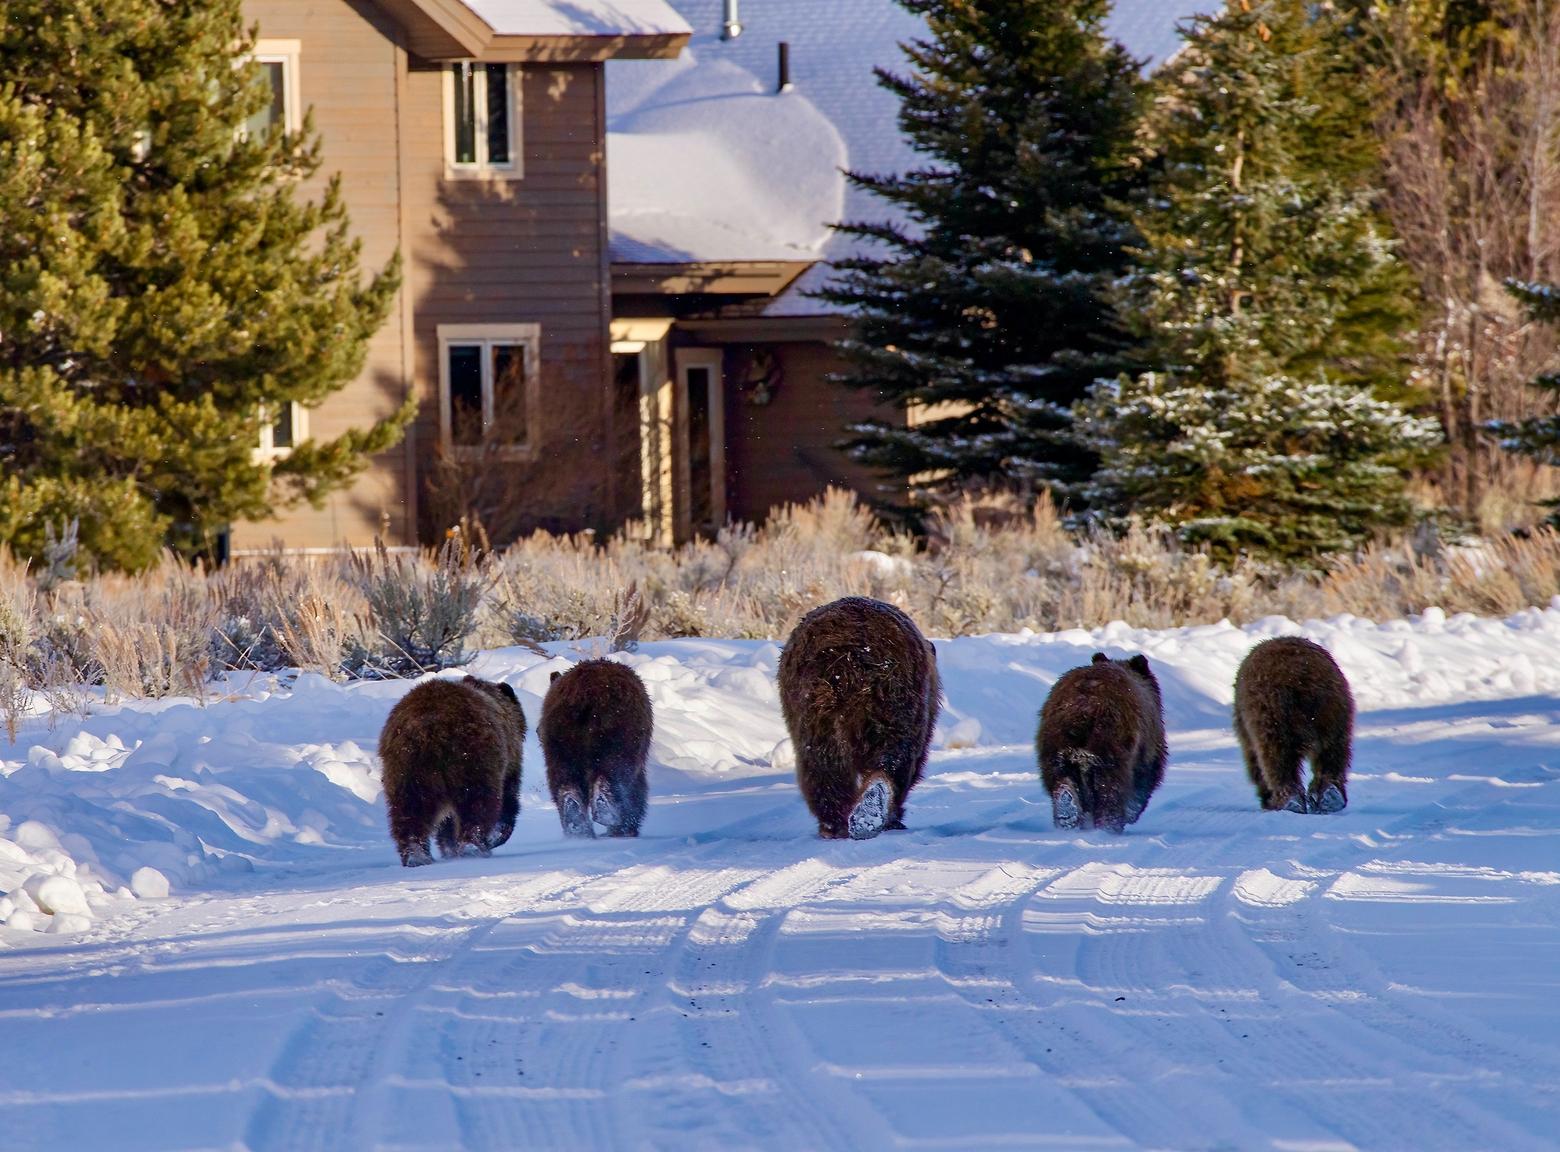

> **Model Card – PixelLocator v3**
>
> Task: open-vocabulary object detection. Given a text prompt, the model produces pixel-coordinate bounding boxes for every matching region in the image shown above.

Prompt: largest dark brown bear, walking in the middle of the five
[778,596,942,840]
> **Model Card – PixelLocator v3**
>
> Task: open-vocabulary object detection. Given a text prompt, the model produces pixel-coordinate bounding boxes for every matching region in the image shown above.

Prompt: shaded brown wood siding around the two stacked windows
[404,56,616,539]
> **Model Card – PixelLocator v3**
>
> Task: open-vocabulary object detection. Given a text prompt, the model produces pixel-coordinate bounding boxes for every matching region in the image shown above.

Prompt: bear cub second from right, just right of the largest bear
[1034,652,1167,832]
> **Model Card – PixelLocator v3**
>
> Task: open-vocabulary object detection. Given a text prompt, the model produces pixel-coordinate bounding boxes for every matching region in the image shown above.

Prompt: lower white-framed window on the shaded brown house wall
[438,325,541,459]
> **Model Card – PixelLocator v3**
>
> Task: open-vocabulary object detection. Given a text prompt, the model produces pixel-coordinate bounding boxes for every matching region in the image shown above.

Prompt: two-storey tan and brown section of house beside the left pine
[232,0,688,553]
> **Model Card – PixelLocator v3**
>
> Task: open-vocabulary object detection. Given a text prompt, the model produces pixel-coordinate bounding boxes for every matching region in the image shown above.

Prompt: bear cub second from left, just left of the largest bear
[537,660,654,837]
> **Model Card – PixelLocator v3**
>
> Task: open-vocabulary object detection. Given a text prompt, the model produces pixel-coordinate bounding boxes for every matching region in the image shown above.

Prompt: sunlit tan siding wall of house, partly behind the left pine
[234,0,415,548]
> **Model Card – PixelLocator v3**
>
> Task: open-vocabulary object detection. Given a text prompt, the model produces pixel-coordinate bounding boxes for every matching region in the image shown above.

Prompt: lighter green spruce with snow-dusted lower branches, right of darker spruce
[1078,0,1438,557]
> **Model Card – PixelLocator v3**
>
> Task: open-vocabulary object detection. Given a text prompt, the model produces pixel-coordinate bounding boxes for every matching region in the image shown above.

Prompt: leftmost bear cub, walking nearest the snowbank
[379,676,526,868]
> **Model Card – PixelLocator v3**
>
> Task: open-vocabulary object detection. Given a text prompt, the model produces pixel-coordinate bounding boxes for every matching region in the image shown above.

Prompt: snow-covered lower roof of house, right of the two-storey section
[605,0,1221,314]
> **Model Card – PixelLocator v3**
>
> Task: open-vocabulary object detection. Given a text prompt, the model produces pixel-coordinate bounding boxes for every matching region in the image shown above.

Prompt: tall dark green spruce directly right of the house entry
[821,0,1142,502]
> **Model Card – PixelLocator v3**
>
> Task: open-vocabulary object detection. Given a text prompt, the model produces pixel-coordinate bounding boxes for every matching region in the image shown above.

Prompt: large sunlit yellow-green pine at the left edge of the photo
[0,0,410,568]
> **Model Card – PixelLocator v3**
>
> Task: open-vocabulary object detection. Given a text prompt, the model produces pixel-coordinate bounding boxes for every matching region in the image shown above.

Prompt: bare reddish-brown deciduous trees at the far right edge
[1354,0,1560,526]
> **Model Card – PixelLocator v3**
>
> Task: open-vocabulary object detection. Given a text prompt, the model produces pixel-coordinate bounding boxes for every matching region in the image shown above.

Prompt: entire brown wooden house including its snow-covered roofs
[234,0,1214,551]
